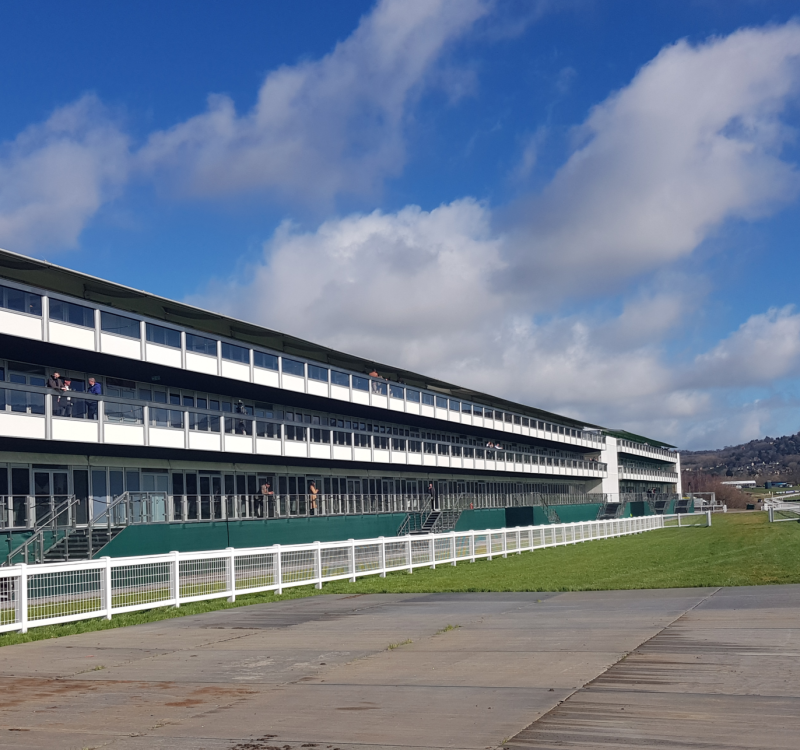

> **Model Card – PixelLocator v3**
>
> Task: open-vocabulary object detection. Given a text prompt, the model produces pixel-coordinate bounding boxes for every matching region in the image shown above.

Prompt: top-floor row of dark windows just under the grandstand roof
[0,286,603,442]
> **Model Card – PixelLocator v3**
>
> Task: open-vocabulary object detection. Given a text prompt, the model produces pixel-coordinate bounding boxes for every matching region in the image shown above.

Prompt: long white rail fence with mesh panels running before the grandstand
[0,513,711,633]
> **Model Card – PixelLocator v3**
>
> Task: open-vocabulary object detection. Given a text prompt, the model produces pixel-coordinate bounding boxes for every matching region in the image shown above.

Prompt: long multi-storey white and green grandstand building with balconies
[0,251,680,561]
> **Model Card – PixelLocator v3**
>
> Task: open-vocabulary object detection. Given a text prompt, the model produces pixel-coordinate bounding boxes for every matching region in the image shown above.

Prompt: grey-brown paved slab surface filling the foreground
[0,585,800,750]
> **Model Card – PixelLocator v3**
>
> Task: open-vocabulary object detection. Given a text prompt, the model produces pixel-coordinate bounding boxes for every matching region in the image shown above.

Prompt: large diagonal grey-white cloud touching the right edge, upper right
[498,23,800,303]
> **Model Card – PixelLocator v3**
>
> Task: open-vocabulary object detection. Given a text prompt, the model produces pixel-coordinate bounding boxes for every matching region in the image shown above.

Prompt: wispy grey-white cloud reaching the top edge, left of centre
[140,0,489,204]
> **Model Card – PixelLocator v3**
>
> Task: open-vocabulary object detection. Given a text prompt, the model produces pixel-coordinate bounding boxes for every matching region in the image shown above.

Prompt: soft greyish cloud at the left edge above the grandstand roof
[0,96,129,252]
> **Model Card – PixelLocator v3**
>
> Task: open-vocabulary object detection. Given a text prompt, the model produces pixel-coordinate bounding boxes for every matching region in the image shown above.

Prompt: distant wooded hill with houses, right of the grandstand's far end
[681,432,800,481]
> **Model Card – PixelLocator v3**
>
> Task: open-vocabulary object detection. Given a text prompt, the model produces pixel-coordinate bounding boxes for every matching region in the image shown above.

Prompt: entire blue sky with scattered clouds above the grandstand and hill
[0,0,800,448]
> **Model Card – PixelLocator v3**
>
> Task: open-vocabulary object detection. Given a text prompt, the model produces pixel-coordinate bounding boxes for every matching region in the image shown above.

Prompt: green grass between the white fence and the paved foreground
[0,513,800,646]
